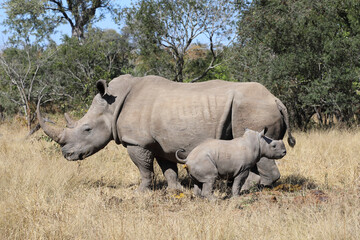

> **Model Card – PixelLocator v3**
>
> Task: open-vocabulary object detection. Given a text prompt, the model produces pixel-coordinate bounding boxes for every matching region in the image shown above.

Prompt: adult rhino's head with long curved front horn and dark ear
[37,80,115,161]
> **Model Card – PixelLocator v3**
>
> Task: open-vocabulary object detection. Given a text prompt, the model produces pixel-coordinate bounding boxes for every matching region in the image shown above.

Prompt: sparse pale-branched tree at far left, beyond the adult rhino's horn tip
[0,45,64,130]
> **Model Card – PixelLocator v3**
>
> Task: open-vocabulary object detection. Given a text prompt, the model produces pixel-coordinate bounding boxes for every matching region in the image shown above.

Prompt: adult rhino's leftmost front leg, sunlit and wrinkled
[127,146,154,192]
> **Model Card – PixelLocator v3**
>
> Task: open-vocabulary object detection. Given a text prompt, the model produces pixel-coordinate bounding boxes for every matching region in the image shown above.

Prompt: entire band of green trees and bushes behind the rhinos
[0,0,360,129]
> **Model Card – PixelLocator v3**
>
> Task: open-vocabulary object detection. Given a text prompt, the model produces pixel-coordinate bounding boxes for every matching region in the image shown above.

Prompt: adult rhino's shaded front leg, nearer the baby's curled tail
[156,157,182,190]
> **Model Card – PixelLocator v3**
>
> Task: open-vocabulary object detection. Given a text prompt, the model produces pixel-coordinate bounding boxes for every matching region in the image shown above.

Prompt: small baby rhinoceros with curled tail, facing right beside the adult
[175,128,286,198]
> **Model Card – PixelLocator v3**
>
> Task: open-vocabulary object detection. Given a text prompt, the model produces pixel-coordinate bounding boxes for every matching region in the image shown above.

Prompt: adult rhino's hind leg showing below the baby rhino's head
[256,157,280,186]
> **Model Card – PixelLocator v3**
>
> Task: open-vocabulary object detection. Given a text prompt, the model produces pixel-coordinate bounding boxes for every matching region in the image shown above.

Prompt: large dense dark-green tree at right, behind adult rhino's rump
[231,0,360,129]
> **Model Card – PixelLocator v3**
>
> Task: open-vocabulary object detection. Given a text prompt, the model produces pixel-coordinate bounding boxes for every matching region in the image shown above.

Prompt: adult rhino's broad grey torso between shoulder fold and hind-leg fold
[118,81,232,149]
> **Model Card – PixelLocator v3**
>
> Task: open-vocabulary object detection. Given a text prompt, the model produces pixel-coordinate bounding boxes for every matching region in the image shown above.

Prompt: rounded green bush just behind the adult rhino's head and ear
[51,28,133,109]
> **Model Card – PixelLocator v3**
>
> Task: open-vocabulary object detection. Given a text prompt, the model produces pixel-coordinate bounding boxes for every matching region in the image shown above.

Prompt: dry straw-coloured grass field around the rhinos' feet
[0,123,360,240]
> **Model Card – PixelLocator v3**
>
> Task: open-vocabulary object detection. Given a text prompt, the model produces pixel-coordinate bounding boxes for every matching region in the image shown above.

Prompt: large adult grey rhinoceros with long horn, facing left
[37,75,295,191]
